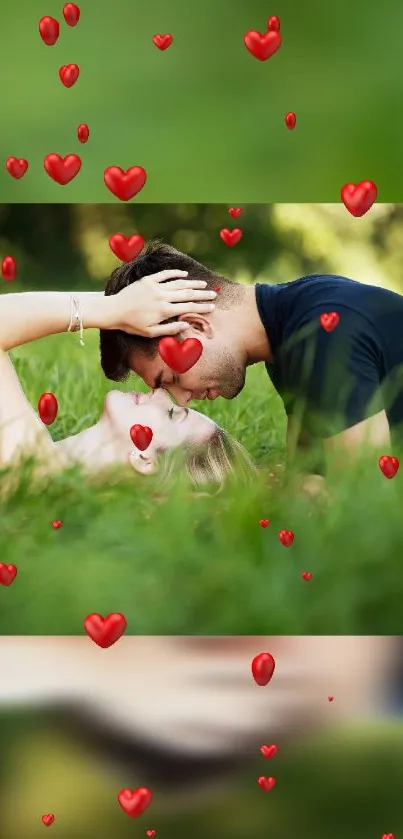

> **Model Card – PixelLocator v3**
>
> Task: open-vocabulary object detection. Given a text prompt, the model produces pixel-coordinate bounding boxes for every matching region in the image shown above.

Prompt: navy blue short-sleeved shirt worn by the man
[256,274,403,438]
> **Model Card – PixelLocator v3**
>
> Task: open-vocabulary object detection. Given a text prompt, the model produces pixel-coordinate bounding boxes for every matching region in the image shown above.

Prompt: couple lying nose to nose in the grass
[0,242,403,494]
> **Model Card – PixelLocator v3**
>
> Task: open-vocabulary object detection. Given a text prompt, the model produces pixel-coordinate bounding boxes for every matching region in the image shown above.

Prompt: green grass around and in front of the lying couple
[0,335,403,635]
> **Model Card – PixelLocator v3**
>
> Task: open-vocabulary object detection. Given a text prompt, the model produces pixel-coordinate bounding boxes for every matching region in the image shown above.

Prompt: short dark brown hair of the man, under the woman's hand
[100,241,239,382]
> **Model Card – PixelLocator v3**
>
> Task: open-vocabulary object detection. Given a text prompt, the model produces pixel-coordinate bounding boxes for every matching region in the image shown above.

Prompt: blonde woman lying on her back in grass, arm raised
[0,271,251,483]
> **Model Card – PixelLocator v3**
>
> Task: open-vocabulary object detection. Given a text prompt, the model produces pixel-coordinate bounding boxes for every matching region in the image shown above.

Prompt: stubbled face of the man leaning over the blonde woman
[130,332,245,405]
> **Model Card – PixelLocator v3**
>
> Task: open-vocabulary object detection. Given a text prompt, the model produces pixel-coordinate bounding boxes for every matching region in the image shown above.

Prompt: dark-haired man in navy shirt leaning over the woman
[101,242,403,491]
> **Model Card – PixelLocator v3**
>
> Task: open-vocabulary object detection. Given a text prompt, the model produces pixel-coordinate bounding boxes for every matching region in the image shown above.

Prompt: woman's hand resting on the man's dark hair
[107,270,217,338]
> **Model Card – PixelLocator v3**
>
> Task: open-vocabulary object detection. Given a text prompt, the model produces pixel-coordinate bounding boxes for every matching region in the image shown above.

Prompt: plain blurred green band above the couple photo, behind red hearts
[0,0,403,203]
